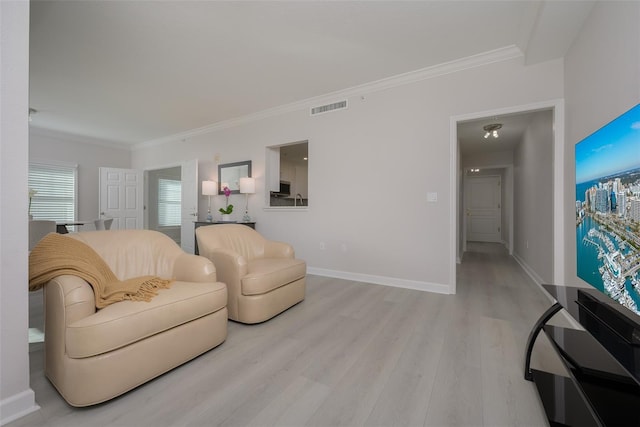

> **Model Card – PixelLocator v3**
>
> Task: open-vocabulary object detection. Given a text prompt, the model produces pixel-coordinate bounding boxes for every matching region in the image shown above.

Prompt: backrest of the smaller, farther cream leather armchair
[196,224,265,261]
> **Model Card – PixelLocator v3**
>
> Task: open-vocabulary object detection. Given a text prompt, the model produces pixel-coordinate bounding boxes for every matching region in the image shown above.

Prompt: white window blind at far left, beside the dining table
[29,163,78,222]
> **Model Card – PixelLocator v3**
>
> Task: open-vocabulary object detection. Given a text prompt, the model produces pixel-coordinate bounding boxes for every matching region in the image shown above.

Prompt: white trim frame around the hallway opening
[449,99,566,294]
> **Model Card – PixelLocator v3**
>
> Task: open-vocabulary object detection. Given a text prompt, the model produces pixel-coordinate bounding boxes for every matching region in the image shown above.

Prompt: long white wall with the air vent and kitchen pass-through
[132,58,563,291]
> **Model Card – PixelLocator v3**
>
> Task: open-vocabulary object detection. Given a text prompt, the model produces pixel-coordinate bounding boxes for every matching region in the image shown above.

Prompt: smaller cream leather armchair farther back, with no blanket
[196,224,307,323]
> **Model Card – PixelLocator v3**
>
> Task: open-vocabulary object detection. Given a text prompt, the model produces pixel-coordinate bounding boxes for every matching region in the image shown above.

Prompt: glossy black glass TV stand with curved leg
[524,285,640,427]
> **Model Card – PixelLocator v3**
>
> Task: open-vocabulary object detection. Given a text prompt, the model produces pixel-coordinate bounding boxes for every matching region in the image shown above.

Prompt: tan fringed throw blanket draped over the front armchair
[29,233,171,308]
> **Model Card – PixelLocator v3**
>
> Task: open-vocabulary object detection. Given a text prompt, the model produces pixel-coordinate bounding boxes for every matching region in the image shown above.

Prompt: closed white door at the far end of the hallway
[465,176,502,242]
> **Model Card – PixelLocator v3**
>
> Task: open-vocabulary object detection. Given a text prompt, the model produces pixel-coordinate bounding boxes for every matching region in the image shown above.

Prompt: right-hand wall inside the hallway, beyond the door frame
[513,110,556,283]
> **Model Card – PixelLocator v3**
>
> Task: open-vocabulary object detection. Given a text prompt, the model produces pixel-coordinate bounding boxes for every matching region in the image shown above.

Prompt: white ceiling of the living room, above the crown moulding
[29,0,593,145]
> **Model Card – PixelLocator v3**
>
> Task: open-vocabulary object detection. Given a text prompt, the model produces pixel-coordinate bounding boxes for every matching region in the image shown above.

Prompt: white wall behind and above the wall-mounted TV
[564,1,640,285]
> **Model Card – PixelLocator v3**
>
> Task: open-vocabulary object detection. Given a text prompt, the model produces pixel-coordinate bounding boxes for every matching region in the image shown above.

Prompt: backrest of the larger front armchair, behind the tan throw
[68,230,184,280]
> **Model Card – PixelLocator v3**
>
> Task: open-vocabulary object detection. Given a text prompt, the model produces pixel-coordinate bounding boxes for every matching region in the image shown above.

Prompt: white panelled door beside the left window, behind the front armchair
[99,167,144,230]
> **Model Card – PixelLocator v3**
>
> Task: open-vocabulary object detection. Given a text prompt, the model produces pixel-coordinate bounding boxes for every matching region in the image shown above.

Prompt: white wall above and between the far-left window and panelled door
[29,128,131,221]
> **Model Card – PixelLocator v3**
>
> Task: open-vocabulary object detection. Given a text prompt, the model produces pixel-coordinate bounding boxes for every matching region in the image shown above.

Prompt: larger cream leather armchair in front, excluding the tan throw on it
[38,230,227,406]
